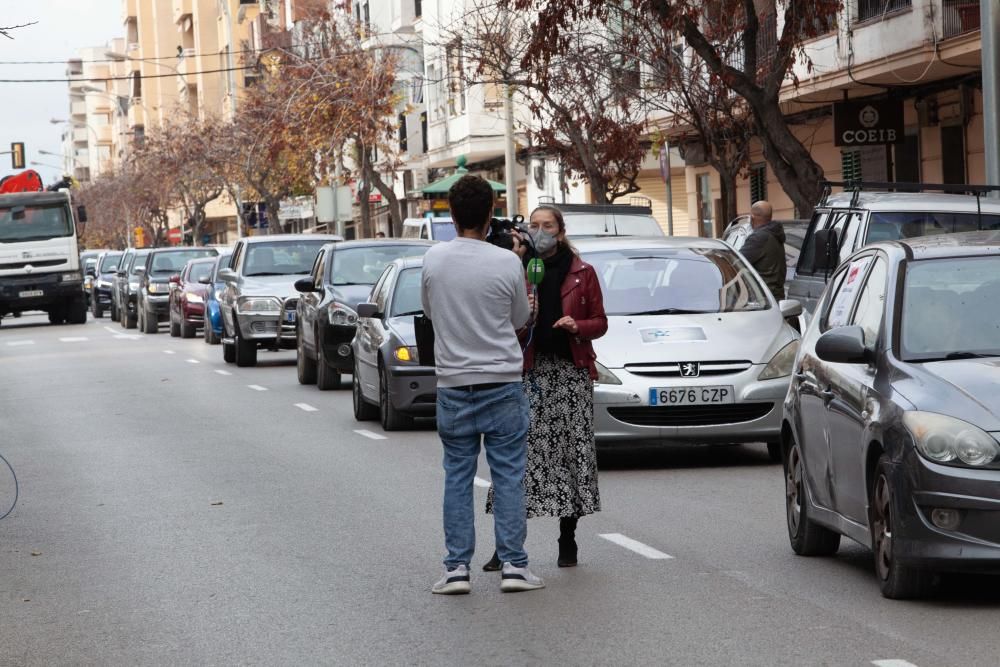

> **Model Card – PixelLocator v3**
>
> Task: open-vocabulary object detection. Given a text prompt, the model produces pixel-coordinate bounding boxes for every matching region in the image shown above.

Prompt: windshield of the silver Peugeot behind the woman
[585,248,769,315]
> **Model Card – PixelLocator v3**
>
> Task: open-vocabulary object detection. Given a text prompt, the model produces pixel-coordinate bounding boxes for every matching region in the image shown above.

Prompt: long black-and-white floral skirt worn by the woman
[486,356,601,518]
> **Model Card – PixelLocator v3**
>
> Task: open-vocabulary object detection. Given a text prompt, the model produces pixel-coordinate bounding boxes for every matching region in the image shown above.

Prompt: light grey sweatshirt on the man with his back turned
[420,237,530,387]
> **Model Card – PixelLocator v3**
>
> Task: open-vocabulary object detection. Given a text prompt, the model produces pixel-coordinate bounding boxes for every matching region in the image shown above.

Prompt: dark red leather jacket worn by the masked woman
[522,257,608,380]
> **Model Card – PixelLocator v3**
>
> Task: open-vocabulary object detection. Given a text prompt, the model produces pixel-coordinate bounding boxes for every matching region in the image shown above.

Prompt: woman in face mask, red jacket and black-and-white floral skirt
[483,205,608,571]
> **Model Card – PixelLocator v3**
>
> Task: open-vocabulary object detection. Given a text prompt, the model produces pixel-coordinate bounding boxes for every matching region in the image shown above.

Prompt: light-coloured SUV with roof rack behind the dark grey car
[787,184,1000,331]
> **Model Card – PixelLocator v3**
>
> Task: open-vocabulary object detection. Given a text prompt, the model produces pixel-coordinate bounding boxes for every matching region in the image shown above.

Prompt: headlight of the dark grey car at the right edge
[903,410,1000,468]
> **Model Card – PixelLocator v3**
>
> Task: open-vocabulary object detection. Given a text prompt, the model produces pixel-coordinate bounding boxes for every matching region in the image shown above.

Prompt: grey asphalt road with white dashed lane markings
[0,316,1000,667]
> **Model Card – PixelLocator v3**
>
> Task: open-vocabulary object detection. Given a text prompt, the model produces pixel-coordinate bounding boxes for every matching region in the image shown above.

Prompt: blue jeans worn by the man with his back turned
[437,382,529,569]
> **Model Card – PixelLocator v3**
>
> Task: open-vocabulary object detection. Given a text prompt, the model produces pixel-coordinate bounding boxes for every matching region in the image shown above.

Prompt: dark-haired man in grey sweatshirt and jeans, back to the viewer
[421,176,545,594]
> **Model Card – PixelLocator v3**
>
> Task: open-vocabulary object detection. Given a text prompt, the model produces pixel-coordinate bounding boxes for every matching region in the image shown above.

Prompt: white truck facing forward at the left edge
[0,191,87,324]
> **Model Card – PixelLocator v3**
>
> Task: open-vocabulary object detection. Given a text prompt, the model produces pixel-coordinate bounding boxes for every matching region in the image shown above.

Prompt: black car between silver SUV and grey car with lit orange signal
[295,239,432,389]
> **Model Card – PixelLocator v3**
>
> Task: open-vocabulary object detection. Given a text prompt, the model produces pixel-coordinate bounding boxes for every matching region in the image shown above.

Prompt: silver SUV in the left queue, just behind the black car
[218,234,343,366]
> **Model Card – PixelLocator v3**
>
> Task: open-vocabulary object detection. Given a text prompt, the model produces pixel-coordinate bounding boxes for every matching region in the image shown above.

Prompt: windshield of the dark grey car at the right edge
[900,257,1000,361]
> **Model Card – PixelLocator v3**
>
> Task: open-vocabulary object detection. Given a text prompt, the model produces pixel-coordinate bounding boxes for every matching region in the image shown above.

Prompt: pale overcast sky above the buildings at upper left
[0,0,124,185]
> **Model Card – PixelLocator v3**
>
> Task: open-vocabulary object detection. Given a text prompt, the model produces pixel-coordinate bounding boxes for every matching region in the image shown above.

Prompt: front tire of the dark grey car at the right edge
[868,454,934,600]
